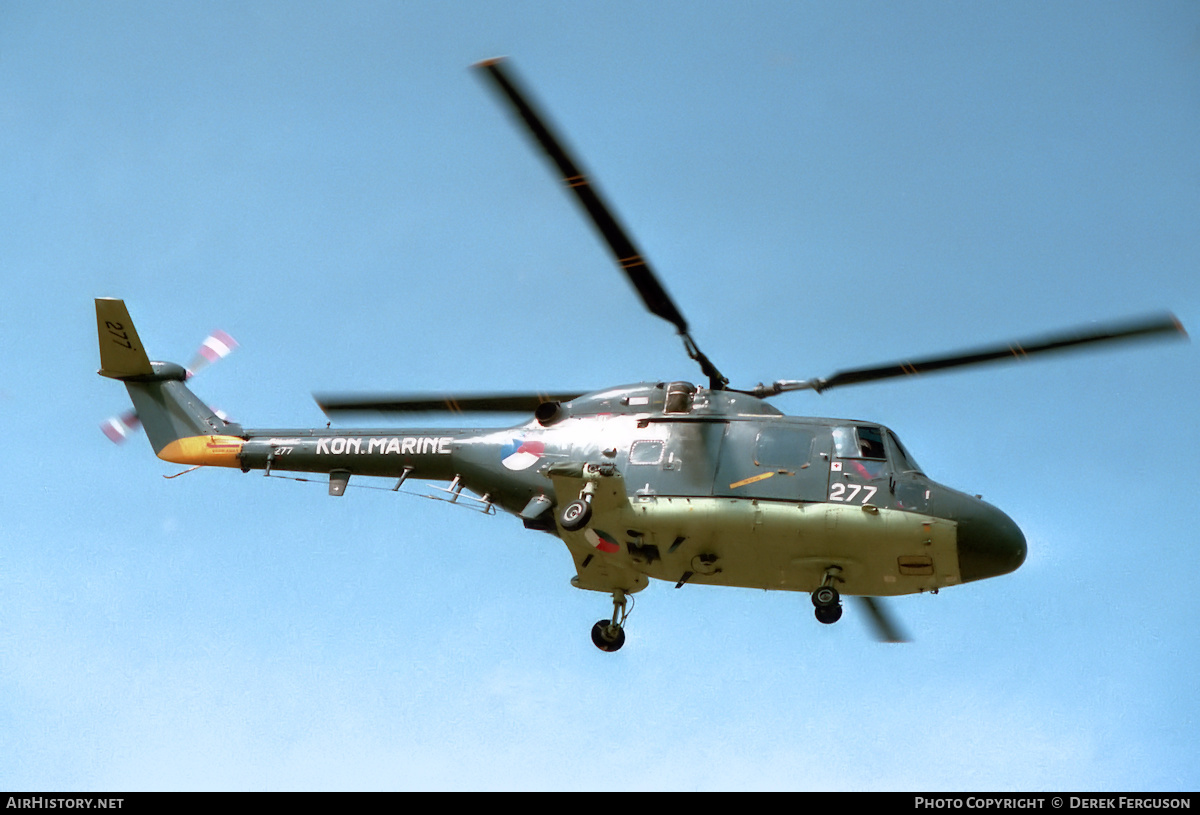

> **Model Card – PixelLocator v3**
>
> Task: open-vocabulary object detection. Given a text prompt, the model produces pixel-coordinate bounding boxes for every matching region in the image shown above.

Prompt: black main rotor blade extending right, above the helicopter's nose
[748,313,1188,397]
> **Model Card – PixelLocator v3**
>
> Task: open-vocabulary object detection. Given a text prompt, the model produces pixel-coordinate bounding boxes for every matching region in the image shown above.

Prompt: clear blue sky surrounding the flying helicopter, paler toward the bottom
[0,2,1200,790]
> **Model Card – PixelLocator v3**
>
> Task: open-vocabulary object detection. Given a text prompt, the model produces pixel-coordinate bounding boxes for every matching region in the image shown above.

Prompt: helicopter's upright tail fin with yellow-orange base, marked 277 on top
[96,298,242,467]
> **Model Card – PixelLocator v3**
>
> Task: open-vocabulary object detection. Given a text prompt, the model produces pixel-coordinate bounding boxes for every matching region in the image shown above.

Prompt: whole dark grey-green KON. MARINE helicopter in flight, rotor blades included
[96,60,1186,652]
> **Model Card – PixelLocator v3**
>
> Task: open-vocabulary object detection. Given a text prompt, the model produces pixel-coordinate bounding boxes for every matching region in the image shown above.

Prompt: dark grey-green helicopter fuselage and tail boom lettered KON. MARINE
[160,382,1026,595]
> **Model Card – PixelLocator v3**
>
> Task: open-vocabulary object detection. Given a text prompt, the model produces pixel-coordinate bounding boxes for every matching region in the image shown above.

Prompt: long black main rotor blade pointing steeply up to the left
[475,59,728,389]
